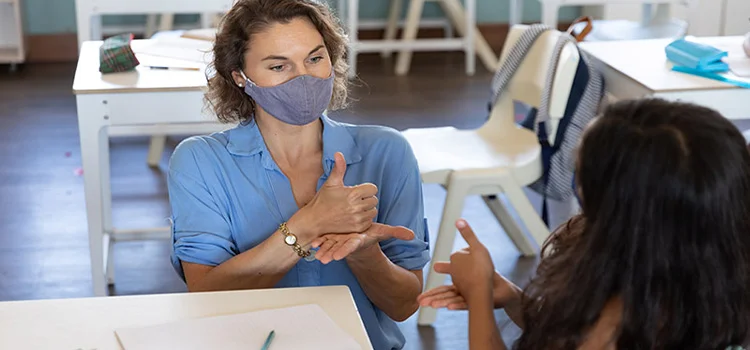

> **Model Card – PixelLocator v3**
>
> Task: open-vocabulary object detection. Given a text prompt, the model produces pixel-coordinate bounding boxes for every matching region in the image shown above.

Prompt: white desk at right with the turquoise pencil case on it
[579,36,750,119]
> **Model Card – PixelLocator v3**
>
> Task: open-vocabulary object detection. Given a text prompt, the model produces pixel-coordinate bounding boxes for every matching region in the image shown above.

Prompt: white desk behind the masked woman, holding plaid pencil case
[73,40,228,296]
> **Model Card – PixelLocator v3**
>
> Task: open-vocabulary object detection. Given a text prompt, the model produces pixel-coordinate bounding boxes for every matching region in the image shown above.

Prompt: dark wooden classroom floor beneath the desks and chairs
[0,54,535,350]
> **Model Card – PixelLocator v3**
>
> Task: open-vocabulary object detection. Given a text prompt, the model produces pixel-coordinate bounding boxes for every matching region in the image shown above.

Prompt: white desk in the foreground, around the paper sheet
[0,286,372,350]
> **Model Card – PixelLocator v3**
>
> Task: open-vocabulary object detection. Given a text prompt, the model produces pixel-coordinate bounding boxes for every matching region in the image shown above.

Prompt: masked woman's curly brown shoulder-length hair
[205,0,349,123]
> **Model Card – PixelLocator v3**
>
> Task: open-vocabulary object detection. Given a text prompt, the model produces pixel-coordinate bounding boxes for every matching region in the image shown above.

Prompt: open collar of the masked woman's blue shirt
[227,114,362,174]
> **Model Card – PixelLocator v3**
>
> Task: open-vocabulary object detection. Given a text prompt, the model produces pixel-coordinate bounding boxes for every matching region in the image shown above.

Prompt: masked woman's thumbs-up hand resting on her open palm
[295,152,378,239]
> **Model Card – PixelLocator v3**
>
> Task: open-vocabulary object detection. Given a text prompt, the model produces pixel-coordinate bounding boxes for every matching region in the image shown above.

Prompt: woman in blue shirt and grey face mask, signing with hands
[169,0,429,349]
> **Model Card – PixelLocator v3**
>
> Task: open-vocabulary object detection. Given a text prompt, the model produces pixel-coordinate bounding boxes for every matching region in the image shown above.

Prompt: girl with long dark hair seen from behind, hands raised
[419,100,750,350]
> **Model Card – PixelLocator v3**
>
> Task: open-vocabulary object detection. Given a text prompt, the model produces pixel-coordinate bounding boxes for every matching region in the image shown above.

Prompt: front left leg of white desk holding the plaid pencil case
[76,95,109,296]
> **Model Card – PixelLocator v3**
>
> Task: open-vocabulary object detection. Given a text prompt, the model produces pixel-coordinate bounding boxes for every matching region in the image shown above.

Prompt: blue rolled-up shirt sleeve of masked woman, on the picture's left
[168,139,238,279]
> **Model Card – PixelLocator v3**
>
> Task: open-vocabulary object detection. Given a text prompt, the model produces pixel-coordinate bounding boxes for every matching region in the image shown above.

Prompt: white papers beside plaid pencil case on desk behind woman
[133,36,213,64]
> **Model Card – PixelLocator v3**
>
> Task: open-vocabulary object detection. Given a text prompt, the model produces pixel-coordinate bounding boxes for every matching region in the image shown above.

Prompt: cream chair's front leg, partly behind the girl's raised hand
[417,183,467,326]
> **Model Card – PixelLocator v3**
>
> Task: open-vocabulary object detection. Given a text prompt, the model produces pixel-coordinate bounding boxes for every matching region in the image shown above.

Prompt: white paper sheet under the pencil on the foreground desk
[115,304,361,350]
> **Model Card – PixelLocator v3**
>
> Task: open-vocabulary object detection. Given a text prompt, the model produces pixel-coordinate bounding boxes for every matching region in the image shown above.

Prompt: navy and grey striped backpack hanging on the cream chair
[489,24,604,225]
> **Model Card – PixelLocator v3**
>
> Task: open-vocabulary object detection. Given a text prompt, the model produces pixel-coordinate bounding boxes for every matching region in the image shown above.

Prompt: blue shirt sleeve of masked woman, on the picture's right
[379,140,430,271]
